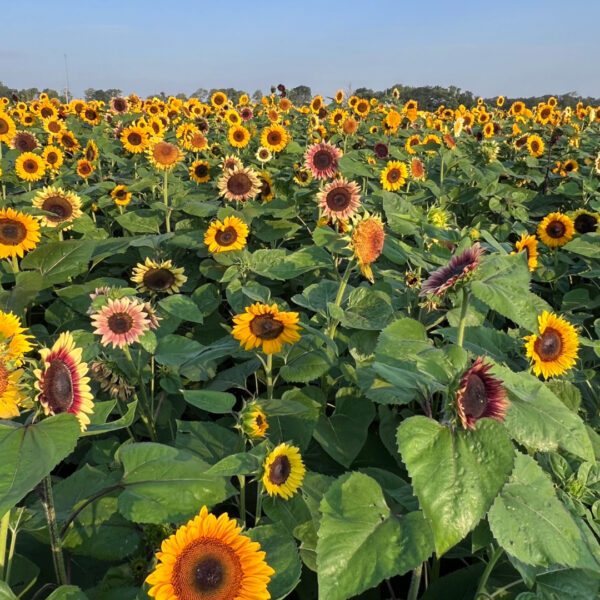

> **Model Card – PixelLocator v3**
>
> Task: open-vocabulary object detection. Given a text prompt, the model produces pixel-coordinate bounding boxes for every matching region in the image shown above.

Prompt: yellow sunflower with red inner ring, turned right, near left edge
[34,332,94,431]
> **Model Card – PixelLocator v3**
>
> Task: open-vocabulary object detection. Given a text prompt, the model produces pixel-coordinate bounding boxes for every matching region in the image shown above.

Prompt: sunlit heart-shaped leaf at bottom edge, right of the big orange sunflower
[317,473,433,600]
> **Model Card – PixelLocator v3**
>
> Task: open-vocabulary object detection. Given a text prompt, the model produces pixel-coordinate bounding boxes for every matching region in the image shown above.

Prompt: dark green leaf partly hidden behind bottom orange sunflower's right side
[246,525,302,600]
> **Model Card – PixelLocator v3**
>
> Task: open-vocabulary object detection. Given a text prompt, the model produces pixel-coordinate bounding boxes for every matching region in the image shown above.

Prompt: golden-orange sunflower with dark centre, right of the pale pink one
[231,302,300,354]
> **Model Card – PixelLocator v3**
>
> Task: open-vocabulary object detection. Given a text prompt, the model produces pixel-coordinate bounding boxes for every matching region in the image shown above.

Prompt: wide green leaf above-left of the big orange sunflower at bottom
[116,442,235,523]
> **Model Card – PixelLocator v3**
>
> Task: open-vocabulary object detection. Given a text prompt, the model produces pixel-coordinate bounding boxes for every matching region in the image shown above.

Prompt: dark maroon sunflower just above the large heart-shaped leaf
[456,356,508,429]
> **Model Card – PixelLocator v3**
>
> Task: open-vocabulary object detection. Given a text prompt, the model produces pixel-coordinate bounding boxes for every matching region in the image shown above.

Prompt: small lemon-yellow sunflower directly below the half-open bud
[262,443,306,500]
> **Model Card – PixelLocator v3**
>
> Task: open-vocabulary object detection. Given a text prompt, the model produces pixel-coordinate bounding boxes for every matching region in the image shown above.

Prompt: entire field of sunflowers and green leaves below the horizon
[0,86,600,600]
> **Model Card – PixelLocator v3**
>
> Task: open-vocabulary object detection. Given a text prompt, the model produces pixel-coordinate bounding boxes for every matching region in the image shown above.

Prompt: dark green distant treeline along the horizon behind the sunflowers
[0,81,600,110]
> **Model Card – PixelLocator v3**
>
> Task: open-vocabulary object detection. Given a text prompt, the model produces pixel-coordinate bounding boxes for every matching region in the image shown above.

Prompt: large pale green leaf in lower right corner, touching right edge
[488,454,600,572]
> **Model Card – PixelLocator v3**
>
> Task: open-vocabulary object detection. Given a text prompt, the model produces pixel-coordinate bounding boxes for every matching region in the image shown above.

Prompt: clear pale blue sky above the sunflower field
[0,0,600,97]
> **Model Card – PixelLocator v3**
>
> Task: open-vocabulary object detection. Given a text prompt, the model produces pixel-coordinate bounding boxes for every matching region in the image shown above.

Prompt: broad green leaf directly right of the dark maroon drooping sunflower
[493,365,594,462]
